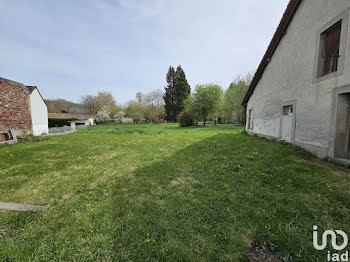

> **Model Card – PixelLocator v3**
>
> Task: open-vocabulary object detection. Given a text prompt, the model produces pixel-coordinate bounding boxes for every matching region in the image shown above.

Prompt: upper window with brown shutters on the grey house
[318,20,342,77]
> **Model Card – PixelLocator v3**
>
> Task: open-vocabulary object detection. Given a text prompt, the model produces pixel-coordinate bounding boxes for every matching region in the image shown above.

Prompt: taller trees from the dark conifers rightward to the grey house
[164,66,252,126]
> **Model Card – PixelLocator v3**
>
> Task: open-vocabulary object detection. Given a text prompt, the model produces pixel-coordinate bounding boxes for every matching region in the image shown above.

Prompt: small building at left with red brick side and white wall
[0,78,48,136]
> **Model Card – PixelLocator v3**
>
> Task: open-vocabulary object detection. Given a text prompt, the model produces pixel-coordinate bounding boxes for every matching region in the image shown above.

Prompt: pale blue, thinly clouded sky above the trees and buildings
[0,0,288,104]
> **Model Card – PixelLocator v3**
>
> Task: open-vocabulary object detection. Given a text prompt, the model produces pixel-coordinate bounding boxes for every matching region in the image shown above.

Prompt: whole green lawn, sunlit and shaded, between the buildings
[0,124,350,262]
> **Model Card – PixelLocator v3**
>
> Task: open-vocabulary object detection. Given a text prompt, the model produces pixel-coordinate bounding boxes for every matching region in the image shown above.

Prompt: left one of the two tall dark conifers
[164,66,175,121]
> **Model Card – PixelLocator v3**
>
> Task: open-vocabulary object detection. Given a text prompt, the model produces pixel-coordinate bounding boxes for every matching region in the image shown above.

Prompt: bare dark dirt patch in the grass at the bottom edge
[247,241,284,262]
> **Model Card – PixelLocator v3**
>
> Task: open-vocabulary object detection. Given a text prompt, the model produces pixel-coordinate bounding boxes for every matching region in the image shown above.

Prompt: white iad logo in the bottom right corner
[313,226,349,261]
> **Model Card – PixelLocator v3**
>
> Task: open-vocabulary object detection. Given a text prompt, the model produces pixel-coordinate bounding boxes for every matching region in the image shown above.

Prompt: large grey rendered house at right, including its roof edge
[243,0,350,162]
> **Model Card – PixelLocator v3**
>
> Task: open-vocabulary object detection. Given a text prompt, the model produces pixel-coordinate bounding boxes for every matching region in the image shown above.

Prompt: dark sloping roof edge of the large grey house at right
[242,0,302,105]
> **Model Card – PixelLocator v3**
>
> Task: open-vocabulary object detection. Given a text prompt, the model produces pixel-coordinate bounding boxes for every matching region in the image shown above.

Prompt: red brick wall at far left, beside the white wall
[0,78,32,136]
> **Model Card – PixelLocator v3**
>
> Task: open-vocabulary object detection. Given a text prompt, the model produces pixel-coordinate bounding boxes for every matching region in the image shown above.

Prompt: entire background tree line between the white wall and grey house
[47,65,252,126]
